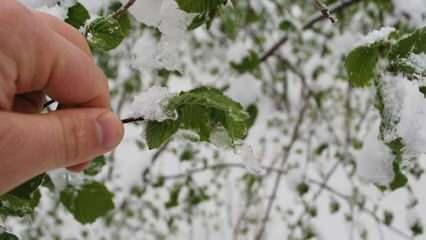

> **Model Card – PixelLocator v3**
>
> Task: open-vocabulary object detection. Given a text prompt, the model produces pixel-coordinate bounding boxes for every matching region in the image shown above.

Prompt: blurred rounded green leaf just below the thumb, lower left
[60,182,114,224]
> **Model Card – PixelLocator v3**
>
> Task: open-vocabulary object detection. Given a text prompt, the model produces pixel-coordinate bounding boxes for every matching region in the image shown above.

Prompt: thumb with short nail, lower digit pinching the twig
[0,109,123,193]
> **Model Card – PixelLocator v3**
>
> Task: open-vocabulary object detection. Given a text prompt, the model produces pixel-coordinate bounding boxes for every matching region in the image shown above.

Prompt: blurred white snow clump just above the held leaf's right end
[225,74,261,107]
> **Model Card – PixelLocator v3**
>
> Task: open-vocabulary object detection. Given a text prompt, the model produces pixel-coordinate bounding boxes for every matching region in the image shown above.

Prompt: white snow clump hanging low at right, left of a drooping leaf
[356,123,394,186]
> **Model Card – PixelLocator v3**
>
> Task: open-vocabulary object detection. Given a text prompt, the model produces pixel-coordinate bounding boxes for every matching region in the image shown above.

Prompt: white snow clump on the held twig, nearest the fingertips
[130,86,175,121]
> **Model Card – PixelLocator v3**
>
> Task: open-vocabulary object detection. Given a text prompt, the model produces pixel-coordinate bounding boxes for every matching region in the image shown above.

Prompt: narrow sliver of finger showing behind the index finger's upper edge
[34,11,92,56]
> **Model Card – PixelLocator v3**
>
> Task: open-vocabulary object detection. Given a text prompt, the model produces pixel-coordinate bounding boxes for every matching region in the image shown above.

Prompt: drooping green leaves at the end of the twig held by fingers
[145,87,250,149]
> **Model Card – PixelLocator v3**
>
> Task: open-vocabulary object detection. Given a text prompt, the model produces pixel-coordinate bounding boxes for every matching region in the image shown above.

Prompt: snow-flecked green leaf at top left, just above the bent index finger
[86,16,125,51]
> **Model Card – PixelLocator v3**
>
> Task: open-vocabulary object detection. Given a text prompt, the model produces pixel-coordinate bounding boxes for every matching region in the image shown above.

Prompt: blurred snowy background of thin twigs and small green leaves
[5,0,426,240]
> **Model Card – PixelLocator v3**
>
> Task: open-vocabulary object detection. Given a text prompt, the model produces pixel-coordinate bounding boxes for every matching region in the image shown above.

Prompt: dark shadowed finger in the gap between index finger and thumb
[12,92,45,113]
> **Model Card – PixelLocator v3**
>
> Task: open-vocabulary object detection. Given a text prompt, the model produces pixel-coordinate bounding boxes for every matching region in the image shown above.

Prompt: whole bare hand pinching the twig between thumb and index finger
[0,0,123,195]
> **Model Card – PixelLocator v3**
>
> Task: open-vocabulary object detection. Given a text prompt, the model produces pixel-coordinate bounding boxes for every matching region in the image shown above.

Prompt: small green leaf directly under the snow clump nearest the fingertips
[145,120,179,149]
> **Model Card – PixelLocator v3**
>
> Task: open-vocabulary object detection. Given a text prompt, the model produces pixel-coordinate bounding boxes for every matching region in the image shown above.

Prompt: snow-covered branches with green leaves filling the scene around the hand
[0,0,426,240]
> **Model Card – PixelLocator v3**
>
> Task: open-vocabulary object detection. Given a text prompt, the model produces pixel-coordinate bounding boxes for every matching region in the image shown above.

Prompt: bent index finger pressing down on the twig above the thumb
[0,1,109,107]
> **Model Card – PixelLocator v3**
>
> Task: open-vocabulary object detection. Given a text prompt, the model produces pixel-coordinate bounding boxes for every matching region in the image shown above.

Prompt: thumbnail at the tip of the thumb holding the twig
[96,112,123,149]
